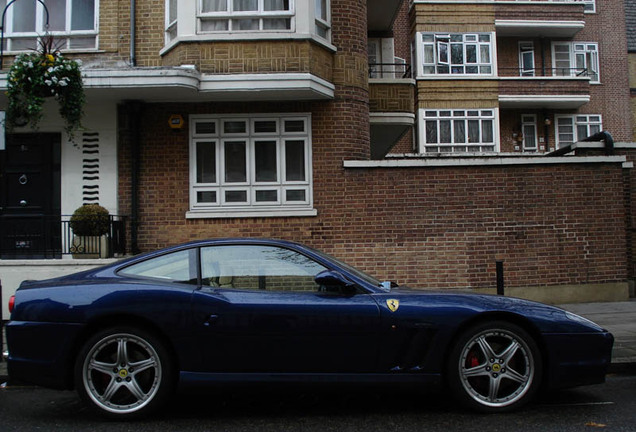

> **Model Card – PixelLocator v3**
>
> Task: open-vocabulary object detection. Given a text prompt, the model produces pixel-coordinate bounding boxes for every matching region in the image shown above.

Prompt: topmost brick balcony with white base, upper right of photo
[495,1,586,38]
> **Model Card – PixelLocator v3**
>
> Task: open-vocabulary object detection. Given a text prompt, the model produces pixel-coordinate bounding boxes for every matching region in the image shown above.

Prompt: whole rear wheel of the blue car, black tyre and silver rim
[75,326,176,419]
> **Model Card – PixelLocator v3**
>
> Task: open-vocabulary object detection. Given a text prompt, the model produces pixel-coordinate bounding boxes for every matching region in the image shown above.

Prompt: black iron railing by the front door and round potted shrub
[0,215,126,259]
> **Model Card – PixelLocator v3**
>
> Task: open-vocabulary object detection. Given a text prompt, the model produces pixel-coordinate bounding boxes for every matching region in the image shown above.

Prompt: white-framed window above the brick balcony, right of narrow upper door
[552,41,601,84]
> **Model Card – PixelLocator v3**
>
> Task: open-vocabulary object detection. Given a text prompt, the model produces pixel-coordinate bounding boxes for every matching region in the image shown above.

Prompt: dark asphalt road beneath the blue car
[0,374,636,432]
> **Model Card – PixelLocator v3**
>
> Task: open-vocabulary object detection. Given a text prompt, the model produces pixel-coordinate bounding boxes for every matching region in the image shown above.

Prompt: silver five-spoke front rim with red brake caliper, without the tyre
[458,329,536,408]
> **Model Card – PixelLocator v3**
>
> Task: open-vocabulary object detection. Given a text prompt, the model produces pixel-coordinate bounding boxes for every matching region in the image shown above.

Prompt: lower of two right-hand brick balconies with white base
[499,68,590,109]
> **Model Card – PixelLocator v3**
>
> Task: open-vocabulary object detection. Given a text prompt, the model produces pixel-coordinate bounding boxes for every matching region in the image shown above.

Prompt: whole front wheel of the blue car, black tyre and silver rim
[446,321,543,413]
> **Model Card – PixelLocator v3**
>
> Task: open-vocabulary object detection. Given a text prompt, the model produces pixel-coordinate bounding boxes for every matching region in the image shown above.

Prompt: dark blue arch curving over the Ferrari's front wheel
[443,311,549,386]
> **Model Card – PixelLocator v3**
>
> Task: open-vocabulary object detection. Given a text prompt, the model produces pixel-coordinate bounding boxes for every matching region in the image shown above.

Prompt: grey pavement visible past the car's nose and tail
[0,298,636,385]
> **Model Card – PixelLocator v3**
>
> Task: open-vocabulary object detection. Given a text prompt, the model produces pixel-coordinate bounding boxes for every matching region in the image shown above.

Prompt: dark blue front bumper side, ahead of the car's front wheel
[545,332,614,388]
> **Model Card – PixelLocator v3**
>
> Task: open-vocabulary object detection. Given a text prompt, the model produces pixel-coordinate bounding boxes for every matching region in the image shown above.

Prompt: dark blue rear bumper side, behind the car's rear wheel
[6,321,82,389]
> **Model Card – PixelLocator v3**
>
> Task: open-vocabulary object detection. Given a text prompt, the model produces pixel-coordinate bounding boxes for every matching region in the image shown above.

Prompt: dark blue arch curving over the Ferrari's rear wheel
[66,314,180,388]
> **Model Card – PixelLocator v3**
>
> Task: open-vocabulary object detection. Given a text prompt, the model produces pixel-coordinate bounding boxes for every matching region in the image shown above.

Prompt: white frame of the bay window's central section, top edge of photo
[197,0,296,35]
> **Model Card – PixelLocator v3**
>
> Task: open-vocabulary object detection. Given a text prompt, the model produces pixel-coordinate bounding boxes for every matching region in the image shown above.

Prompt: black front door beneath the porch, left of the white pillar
[0,133,62,259]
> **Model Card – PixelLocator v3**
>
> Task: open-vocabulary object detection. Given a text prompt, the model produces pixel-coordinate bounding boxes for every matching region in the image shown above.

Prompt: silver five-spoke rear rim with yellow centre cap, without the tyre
[82,333,162,414]
